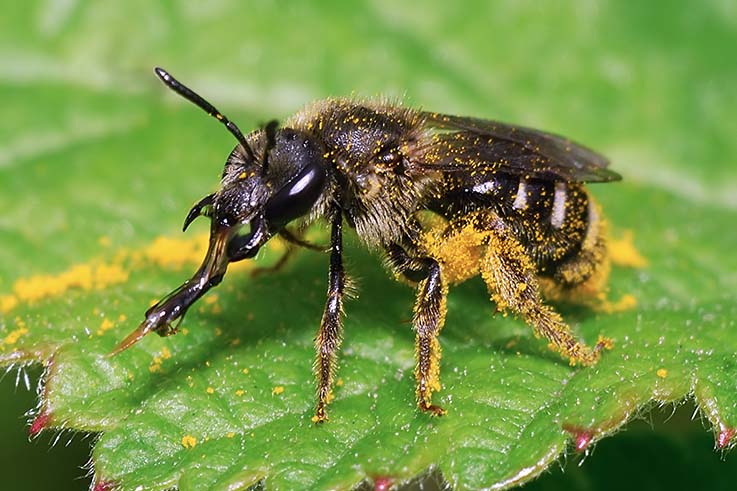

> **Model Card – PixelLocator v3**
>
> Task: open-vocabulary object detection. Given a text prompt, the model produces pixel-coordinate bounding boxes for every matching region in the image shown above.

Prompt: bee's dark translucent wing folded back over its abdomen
[421,112,621,182]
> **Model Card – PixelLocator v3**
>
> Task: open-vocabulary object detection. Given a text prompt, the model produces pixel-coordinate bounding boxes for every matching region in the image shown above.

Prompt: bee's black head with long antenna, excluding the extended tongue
[154,67,327,261]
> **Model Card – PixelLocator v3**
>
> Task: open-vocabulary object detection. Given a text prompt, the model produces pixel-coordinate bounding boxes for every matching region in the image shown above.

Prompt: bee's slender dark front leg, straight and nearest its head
[312,209,345,423]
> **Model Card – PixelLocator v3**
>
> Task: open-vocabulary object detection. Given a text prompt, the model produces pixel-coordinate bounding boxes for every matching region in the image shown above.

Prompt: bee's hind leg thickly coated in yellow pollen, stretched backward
[481,216,611,366]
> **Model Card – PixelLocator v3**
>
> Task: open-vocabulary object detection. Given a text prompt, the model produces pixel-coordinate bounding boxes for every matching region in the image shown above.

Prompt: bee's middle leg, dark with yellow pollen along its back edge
[387,244,448,416]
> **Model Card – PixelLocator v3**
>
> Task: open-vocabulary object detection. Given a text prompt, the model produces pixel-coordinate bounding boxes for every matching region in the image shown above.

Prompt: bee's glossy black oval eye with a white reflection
[264,162,326,229]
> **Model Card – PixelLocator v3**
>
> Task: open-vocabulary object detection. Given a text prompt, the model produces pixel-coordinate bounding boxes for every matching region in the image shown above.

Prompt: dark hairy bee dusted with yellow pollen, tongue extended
[114,68,621,422]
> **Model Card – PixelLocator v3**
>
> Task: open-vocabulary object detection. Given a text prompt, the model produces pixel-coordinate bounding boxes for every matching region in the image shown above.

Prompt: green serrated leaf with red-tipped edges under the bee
[0,1,737,491]
